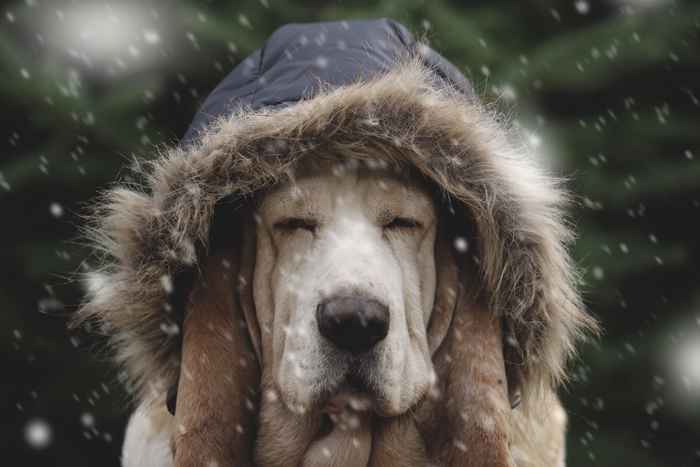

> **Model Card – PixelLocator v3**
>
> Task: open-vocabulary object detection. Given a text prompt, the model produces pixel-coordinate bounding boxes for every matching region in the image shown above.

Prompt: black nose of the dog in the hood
[316,296,389,354]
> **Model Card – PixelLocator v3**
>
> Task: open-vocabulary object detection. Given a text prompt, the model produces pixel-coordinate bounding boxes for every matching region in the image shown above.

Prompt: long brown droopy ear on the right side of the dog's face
[416,224,513,467]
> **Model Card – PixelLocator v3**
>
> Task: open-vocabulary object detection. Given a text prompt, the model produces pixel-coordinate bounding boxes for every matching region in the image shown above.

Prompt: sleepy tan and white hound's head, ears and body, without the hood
[117,162,566,467]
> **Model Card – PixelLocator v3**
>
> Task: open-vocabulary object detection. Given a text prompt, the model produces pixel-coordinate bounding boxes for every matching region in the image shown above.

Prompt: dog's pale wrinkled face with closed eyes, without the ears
[253,167,437,415]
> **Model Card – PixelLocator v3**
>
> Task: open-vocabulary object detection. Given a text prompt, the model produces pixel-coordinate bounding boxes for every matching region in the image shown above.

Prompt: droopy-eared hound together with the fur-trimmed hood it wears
[78,20,595,467]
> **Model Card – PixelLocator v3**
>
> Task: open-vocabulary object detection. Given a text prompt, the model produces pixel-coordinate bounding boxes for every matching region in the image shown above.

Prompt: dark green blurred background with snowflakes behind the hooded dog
[0,0,700,467]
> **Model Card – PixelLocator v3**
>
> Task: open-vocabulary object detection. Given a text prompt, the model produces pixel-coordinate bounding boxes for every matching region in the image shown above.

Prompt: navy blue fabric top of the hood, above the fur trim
[182,19,472,145]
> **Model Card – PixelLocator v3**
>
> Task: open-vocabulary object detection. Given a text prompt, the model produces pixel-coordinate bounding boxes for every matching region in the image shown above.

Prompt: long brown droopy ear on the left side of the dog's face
[174,218,260,466]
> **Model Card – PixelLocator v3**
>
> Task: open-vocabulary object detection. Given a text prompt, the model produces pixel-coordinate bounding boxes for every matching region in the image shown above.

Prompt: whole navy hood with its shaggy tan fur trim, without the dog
[77,20,593,406]
